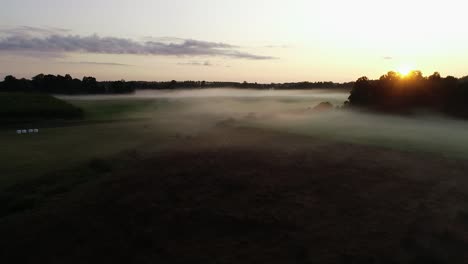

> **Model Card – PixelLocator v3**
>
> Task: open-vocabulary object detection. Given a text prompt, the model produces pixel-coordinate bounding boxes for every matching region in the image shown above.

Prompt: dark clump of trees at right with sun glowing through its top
[345,71,468,118]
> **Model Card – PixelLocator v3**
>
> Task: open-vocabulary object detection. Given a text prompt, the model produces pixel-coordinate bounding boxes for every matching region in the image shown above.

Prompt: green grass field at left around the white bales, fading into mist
[0,96,234,190]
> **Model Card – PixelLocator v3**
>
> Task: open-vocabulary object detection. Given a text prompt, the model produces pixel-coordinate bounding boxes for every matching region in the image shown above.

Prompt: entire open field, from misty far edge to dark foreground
[0,89,468,263]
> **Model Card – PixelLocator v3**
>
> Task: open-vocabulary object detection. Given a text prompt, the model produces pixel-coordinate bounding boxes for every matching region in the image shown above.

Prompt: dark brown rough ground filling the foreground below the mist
[0,127,468,263]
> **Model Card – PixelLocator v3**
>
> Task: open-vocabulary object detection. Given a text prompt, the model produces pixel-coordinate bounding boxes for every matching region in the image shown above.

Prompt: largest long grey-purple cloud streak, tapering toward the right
[0,27,275,60]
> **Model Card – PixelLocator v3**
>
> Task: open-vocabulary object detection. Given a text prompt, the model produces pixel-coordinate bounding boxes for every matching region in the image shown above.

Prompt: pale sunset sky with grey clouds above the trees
[0,0,468,83]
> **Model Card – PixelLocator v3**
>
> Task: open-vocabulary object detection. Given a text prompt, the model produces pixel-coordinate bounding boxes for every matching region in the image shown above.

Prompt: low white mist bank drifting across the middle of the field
[60,89,468,158]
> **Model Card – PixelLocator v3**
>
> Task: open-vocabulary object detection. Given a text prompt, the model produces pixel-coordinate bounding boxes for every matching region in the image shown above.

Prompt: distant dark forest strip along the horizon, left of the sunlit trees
[0,74,353,95]
